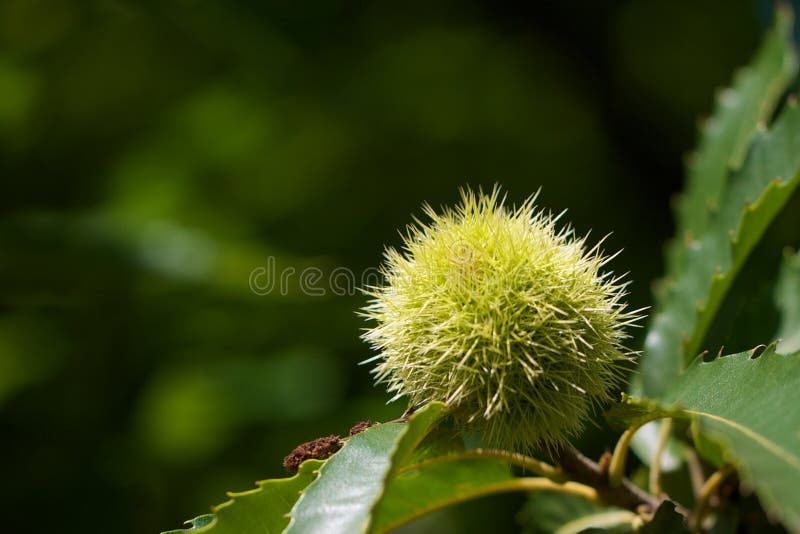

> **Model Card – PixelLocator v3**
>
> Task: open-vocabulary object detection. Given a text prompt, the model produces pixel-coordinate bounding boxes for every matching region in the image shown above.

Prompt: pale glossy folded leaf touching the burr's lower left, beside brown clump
[286,403,445,534]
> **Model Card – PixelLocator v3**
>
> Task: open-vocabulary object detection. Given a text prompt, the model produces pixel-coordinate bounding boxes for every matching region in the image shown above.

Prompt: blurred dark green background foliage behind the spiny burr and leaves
[0,0,792,533]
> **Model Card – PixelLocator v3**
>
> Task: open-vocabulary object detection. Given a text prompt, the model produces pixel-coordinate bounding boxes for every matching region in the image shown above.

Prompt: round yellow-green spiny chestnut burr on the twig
[362,188,640,452]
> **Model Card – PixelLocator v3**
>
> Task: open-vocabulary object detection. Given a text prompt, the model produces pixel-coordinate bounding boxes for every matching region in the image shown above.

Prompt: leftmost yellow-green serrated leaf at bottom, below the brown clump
[163,460,324,534]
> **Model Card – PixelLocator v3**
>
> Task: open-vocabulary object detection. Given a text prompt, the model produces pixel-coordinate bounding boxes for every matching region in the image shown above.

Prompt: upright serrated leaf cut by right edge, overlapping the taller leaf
[641,94,800,397]
